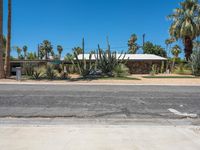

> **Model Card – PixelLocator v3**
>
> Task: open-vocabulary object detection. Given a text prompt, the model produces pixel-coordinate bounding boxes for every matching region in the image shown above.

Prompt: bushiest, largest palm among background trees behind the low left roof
[40,40,53,60]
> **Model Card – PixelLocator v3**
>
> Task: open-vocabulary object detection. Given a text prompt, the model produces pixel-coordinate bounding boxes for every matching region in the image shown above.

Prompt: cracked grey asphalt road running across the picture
[0,85,200,119]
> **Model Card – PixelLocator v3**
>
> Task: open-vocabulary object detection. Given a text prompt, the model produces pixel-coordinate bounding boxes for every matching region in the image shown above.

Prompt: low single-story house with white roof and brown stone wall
[11,54,167,74]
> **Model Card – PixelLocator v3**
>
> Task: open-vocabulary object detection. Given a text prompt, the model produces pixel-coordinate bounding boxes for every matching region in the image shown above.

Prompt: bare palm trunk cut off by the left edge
[0,0,5,79]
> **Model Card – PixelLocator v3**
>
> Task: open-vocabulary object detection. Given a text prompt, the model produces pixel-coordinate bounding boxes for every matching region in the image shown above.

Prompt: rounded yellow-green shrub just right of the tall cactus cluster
[113,64,129,77]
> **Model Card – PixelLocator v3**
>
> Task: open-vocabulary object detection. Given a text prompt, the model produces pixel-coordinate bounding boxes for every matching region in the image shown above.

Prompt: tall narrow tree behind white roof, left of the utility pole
[128,34,139,54]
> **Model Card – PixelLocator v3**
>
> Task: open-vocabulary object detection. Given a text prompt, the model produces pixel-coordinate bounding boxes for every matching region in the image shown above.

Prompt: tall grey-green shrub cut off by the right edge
[190,47,200,76]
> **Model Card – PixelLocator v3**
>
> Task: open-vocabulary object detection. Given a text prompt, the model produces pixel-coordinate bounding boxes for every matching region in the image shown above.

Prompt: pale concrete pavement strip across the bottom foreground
[0,124,200,150]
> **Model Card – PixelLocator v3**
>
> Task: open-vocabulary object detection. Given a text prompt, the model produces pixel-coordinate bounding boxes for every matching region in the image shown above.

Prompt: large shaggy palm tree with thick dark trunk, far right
[168,0,200,60]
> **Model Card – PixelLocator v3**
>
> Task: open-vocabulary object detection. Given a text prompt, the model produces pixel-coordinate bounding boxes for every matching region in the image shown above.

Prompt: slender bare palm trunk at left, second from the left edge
[5,0,12,77]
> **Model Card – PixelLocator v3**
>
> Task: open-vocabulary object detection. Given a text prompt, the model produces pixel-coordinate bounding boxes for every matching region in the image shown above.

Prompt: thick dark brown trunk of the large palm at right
[184,36,193,61]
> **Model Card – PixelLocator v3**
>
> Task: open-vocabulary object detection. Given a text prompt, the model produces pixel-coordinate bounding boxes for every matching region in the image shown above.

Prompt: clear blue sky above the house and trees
[4,0,184,55]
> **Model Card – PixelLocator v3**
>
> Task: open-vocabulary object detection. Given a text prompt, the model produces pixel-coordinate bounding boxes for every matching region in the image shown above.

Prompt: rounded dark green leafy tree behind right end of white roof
[143,42,167,57]
